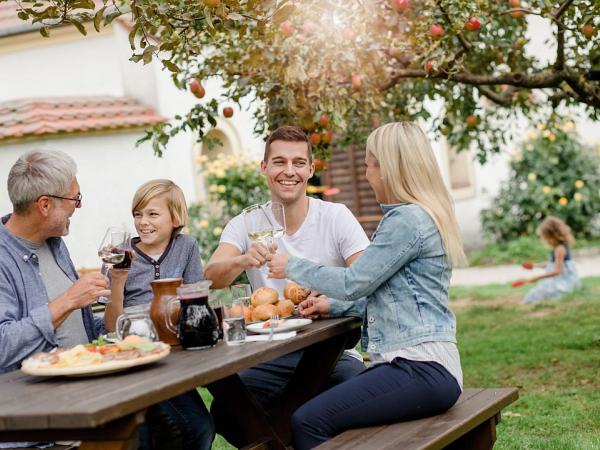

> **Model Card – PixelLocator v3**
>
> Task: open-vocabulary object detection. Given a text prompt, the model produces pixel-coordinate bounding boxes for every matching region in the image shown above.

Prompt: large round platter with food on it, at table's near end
[21,335,171,376]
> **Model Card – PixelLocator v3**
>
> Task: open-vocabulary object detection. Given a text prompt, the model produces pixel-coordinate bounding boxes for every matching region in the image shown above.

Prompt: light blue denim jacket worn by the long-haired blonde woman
[286,203,456,353]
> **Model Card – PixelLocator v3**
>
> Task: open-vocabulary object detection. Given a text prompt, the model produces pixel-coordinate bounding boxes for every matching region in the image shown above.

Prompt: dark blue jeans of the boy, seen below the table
[140,390,215,450]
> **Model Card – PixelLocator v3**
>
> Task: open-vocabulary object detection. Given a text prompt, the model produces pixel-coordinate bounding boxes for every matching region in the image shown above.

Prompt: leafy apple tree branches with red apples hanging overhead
[10,0,600,160]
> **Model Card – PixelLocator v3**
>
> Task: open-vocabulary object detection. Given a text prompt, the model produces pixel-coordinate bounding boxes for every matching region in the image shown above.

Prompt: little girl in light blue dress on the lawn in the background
[513,216,581,303]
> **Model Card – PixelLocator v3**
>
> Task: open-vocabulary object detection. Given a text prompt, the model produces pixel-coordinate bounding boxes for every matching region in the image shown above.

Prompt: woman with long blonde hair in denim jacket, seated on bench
[268,122,465,449]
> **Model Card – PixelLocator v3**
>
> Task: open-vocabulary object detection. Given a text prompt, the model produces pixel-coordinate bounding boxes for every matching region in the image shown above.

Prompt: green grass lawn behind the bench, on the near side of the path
[203,278,600,450]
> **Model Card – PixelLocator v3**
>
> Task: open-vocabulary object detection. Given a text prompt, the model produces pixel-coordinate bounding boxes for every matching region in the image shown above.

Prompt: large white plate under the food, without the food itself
[21,342,171,377]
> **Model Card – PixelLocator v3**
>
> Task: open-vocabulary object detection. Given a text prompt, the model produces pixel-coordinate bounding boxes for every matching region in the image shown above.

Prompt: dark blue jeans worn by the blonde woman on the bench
[292,358,461,450]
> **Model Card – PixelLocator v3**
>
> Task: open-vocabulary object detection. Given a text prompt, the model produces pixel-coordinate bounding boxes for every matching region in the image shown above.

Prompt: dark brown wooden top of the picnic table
[0,318,360,431]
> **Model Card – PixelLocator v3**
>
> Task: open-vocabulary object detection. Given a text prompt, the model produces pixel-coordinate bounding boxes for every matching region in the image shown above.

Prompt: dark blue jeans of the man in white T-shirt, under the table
[210,351,365,448]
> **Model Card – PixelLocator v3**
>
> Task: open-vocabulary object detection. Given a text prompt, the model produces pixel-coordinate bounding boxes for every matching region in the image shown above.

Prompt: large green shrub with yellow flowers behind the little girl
[481,122,600,242]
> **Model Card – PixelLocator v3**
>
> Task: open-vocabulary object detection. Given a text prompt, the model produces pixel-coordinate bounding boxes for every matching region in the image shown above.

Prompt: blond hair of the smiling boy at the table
[131,179,188,235]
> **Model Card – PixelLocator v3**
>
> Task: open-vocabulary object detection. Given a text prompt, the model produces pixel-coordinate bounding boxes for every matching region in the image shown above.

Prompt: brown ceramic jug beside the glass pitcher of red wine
[150,278,183,345]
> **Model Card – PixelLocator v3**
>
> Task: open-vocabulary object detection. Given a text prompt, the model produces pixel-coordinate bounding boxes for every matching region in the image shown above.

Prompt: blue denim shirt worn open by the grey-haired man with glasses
[0,215,103,373]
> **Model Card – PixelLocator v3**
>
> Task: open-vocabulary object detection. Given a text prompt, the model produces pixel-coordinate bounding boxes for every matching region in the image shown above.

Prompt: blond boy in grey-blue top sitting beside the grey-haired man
[104,179,215,450]
